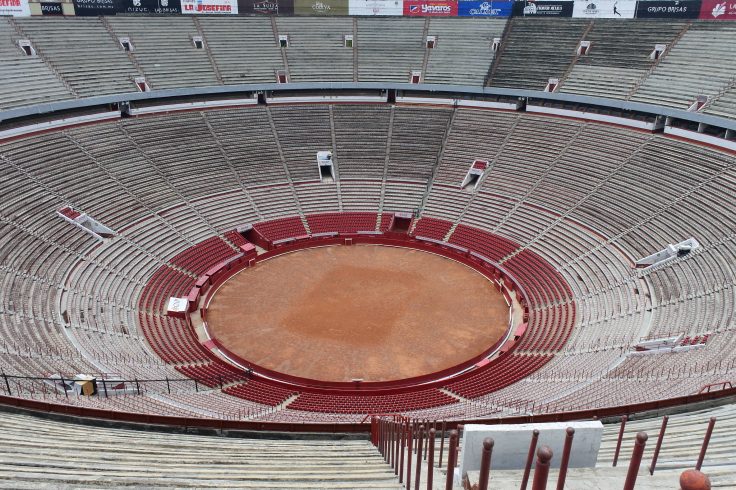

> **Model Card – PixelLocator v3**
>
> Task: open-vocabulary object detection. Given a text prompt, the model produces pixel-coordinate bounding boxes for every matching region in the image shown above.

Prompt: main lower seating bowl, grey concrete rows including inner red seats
[0,101,736,421]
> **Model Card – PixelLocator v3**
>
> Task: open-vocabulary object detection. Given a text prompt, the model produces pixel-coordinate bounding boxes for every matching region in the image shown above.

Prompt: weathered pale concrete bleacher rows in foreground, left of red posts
[0,413,400,490]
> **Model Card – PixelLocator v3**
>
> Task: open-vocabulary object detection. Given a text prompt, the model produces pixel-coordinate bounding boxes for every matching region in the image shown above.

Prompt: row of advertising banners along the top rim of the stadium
[8,0,736,20]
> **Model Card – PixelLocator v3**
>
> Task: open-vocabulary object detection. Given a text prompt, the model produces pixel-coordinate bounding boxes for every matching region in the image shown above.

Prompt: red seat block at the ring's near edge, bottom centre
[289,389,457,413]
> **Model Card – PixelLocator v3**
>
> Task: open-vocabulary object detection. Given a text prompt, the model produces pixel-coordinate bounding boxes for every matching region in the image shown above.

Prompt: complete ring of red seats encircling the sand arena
[139,212,576,414]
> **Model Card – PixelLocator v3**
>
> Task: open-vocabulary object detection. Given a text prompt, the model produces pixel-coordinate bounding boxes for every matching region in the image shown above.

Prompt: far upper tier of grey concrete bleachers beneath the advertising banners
[0,16,734,128]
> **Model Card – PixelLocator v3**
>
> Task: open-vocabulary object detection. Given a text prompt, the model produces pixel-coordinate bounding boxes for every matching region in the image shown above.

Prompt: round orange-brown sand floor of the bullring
[207,245,508,381]
